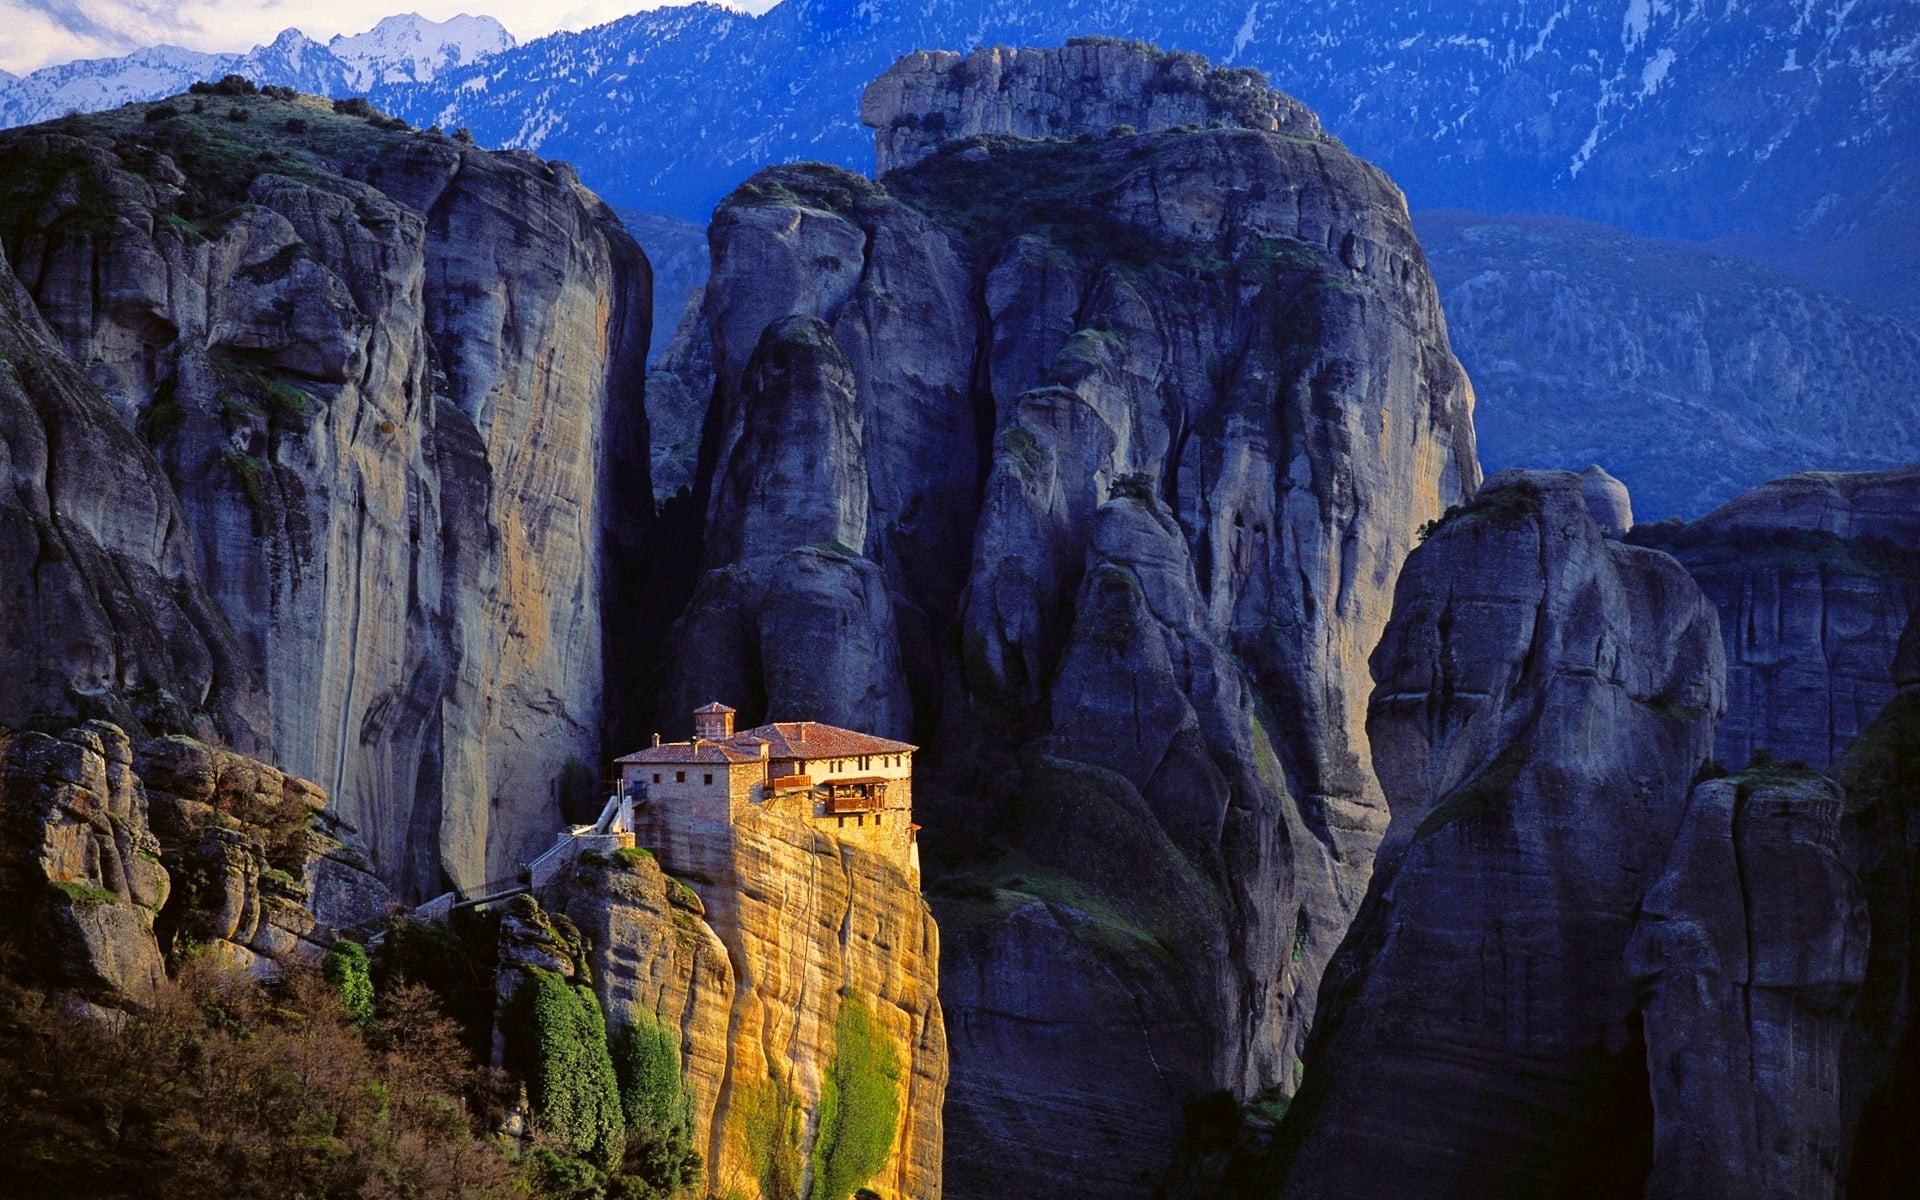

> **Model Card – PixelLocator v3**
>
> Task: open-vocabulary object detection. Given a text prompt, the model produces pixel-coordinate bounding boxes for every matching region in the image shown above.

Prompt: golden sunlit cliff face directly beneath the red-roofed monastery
[541,812,947,1200]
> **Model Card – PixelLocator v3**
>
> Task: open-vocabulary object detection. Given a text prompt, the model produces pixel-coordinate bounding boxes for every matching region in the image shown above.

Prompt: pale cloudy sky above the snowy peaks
[0,0,776,75]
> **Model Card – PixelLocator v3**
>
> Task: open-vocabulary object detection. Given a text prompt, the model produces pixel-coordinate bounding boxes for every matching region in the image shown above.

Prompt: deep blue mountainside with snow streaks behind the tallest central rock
[374,0,1920,236]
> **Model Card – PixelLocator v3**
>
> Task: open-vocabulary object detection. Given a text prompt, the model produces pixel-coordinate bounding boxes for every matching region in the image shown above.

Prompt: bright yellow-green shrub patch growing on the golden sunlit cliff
[812,995,900,1200]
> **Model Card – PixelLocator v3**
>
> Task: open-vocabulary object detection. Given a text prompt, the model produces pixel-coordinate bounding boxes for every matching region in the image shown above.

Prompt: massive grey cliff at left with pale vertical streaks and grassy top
[0,96,651,893]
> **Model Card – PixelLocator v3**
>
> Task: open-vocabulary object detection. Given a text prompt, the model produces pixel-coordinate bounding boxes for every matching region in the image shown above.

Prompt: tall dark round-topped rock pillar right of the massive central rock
[1281,470,1724,1196]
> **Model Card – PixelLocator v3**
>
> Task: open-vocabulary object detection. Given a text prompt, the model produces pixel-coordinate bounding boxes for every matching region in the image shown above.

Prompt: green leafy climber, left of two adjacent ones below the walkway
[507,968,626,1169]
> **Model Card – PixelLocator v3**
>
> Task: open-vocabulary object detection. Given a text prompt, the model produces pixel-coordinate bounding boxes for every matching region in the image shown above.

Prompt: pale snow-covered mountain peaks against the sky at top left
[0,13,515,127]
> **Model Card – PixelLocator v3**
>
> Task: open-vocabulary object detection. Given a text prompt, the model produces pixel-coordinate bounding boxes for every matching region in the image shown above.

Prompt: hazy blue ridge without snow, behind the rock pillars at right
[1413,211,1920,520]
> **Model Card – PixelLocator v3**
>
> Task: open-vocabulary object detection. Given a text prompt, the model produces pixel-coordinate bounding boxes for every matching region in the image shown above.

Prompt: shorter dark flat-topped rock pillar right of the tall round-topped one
[1628,770,1885,1200]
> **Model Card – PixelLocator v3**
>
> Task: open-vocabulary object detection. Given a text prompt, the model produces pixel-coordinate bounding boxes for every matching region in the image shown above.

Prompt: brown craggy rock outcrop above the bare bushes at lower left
[0,720,386,1008]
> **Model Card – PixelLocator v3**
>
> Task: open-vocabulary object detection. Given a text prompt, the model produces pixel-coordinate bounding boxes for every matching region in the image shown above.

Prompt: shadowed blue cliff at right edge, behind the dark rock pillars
[1634,467,1920,770]
